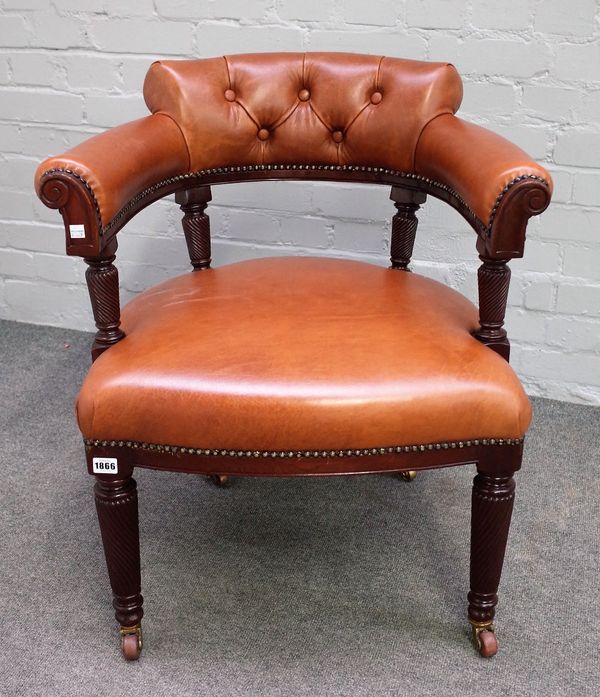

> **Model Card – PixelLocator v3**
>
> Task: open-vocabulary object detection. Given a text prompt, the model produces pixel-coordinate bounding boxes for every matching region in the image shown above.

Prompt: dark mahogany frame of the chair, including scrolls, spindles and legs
[41,165,550,658]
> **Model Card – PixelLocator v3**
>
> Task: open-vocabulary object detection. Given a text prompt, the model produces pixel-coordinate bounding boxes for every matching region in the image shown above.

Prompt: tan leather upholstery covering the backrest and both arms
[36,53,551,237]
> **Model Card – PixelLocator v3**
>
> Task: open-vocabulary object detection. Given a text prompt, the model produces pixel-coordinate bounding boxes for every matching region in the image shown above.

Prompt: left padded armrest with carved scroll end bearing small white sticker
[35,114,189,257]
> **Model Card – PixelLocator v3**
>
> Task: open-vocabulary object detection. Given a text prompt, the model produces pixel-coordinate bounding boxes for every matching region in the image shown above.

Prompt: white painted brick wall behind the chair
[0,0,600,404]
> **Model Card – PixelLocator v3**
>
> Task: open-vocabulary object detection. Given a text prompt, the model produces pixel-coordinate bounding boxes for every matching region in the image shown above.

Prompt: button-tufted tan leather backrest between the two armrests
[144,53,462,172]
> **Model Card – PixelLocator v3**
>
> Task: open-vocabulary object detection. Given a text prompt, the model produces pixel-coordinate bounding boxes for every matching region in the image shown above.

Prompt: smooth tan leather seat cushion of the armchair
[77,257,530,451]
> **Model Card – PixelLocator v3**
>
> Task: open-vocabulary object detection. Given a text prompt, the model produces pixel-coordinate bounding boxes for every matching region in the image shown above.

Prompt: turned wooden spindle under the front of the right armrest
[475,255,510,360]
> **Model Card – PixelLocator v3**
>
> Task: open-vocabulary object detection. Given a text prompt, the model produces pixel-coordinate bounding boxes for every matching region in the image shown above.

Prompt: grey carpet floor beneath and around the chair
[0,322,600,697]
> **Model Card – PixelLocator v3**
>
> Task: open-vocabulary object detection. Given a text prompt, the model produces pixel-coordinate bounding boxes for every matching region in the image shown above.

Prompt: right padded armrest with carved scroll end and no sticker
[415,114,552,259]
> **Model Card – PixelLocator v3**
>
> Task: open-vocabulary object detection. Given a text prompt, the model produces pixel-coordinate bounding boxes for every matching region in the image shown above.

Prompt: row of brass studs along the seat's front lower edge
[83,438,524,458]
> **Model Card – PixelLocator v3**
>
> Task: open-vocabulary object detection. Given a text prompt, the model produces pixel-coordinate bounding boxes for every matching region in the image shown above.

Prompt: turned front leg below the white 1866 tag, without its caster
[94,475,144,629]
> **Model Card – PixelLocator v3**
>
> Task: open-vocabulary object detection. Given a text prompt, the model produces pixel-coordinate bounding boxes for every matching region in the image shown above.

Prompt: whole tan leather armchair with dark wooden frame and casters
[36,53,552,659]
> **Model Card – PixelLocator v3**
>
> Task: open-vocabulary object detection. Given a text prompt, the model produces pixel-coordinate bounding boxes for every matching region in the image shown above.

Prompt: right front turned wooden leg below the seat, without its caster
[468,472,515,628]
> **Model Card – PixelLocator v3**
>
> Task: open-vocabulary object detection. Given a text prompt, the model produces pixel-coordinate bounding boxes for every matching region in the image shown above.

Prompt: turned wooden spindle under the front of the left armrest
[84,238,125,361]
